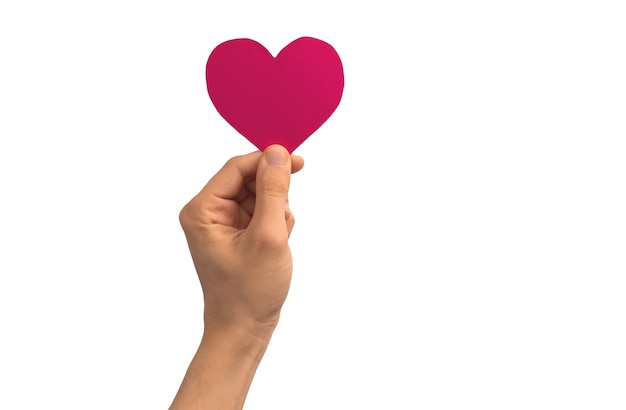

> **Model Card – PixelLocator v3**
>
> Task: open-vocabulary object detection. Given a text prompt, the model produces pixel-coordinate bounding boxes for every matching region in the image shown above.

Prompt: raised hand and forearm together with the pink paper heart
[170,37,343,410]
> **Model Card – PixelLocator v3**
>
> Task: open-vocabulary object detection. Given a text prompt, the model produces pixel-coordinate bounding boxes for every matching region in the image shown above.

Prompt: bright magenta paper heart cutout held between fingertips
[206,37,343,152]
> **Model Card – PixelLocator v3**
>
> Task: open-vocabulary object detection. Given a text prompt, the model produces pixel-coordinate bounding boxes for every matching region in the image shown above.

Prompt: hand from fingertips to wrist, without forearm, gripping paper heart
[180,145,304,334]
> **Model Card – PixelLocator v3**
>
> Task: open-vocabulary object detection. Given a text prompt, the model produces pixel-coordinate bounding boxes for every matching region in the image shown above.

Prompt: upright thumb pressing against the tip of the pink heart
[250,145,291,244]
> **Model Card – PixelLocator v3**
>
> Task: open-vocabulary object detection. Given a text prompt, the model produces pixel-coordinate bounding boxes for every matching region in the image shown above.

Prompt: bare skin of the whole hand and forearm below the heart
[170,145,304,410]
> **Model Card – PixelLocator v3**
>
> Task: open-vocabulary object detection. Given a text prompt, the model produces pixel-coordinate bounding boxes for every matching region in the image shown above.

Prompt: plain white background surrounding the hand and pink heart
[0,0,626,410]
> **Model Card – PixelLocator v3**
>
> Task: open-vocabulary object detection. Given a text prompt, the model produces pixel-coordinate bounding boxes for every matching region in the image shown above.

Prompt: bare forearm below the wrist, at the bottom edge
[170,327,273,410]
